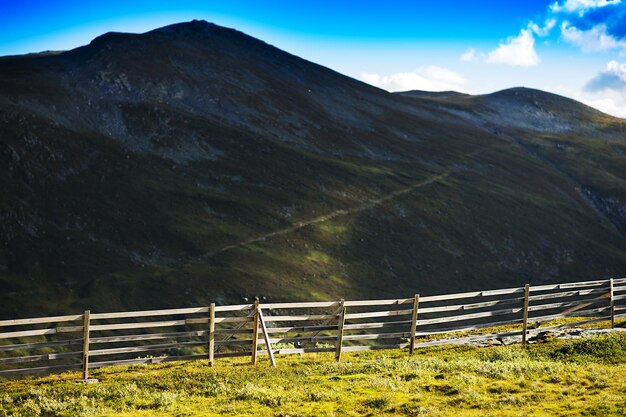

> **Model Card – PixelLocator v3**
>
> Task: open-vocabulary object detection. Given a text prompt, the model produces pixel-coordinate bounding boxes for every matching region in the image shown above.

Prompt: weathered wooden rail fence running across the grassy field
[0,278,626,379]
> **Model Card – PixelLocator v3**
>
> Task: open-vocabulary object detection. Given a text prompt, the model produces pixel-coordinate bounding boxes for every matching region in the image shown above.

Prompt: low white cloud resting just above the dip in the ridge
[361,65,467,91]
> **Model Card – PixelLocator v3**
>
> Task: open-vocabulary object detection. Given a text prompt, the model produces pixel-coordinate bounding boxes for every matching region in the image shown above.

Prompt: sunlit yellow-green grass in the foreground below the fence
[0,335,626,417]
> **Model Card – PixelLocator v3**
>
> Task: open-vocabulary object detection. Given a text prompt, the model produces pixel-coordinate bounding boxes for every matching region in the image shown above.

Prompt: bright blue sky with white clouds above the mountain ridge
[0,0,626,117]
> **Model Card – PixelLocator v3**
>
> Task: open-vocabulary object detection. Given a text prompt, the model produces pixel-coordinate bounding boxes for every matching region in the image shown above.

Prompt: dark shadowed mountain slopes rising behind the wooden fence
[0,21,626,317]
